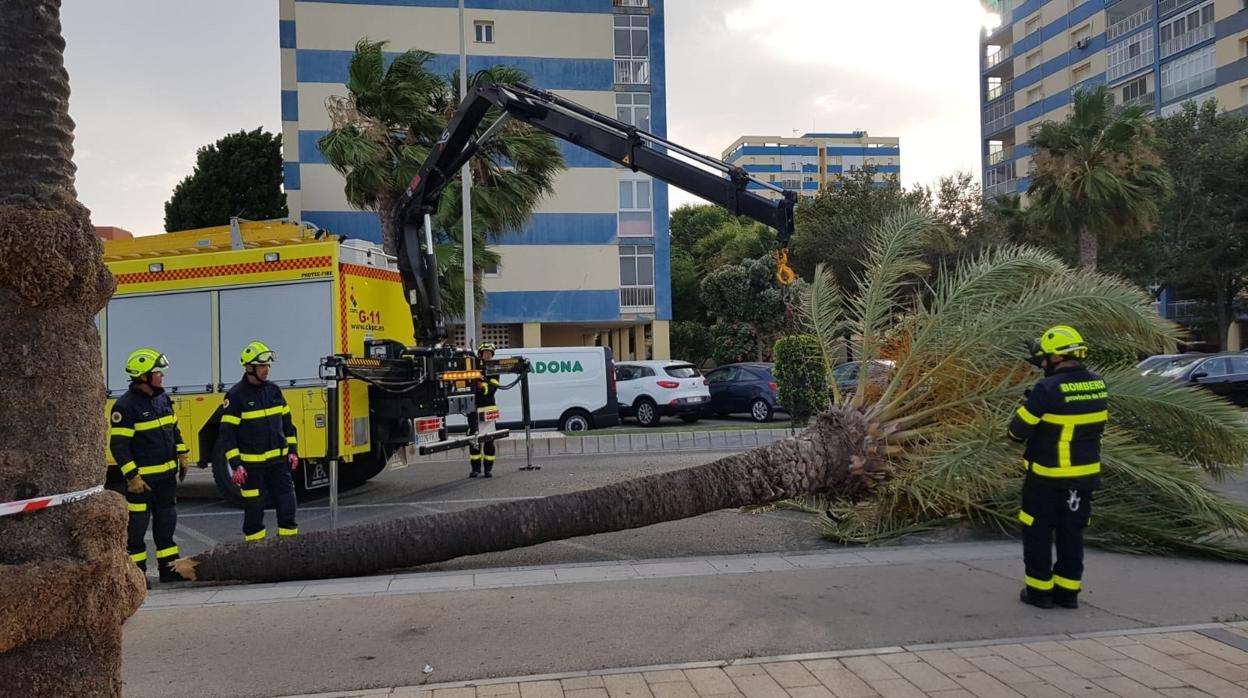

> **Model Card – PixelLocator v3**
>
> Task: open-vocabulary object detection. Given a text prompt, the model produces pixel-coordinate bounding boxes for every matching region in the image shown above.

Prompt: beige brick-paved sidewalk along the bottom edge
[280,622,1248,698]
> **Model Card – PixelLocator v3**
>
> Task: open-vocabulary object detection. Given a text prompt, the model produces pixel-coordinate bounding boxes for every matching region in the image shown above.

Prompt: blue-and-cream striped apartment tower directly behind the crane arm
[280,0,671,358]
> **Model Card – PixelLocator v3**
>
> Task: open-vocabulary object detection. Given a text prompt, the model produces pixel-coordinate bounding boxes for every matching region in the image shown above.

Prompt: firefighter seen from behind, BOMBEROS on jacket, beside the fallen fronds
[1010,325,1109,608]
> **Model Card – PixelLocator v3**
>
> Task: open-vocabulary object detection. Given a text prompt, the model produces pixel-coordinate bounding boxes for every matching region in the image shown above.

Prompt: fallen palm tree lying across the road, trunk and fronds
[178,206,1248,582]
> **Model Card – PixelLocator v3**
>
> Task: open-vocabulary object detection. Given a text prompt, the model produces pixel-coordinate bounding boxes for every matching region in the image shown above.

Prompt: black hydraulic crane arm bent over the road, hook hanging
[394,85,797,346]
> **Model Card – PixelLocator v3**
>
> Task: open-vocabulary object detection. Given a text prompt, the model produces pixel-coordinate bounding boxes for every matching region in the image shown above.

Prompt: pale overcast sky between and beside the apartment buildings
[61,0,985,235]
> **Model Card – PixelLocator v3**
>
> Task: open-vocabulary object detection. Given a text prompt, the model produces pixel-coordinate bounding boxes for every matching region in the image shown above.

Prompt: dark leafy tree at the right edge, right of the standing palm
[1141,100,1248,341]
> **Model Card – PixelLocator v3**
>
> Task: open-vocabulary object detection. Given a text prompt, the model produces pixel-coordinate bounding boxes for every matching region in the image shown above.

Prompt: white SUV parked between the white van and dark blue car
[615,361,710,427]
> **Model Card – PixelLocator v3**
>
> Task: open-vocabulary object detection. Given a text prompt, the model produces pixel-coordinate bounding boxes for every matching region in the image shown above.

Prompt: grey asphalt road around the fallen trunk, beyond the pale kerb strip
[170,453,839,569]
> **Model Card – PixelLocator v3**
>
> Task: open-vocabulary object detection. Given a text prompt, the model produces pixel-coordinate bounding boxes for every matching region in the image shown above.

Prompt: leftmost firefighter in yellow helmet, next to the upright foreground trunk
[105,348,190,588]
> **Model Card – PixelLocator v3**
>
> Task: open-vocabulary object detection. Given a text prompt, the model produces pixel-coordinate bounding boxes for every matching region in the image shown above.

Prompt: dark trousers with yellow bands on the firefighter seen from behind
[1018,479,1092,597]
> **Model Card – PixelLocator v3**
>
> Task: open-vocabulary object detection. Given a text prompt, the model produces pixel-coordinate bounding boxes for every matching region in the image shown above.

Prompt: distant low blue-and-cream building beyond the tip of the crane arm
[723,131,901,199]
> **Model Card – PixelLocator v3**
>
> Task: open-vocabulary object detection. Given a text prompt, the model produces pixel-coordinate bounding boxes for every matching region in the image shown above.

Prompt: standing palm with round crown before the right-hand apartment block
[1027,85,1169,270]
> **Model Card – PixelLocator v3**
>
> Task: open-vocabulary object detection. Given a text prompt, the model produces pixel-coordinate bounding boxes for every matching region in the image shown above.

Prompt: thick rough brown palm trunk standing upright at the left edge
[0,0,144,697]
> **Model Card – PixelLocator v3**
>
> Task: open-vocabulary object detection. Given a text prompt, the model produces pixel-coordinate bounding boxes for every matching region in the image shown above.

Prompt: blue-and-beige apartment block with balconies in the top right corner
[980,0,1248,197]
